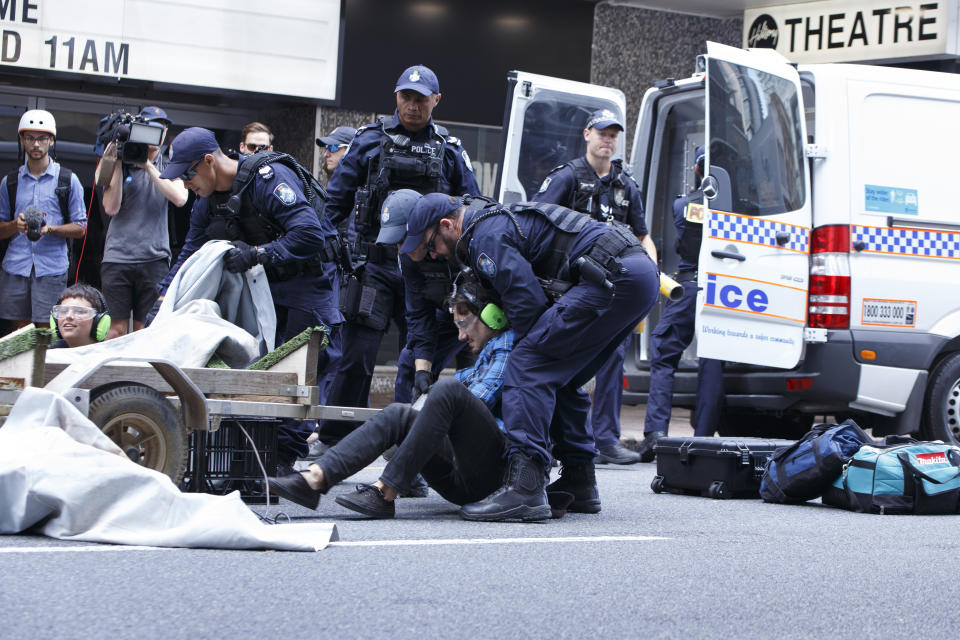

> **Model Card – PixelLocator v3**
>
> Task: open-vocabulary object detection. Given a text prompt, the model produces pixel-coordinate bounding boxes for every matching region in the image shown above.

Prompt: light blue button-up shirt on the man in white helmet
[0,160,87,278]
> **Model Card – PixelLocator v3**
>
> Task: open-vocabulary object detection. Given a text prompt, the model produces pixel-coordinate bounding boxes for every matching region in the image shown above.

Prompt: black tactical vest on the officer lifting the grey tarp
[206,151,327,246]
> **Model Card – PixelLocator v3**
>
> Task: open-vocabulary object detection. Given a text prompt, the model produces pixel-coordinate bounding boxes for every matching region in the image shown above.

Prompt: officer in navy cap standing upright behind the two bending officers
[320,65,480,443]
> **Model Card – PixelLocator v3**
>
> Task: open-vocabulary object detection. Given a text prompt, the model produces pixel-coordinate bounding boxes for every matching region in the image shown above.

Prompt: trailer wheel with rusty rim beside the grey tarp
[90,383,190,484]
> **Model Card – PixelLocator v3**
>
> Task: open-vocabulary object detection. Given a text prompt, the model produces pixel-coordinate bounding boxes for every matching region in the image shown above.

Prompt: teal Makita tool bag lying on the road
[823,436,960,514]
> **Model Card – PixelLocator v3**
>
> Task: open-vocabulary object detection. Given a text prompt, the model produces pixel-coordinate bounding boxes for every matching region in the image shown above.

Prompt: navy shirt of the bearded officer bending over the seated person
[463,202,610,340]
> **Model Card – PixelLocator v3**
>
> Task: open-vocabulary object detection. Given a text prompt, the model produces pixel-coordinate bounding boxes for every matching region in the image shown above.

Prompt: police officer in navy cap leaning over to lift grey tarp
[161,127,343,473]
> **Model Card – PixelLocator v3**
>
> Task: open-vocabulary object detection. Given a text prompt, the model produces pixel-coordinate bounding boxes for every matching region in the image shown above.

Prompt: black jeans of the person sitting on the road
[317,378,507,505]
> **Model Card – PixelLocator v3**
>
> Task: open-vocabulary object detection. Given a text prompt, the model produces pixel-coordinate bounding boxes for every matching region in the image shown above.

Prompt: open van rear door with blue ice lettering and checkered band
[697,42,811,369]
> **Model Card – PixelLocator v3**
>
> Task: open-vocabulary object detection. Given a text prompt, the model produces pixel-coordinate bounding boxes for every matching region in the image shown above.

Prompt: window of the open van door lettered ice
[707,58,806,216]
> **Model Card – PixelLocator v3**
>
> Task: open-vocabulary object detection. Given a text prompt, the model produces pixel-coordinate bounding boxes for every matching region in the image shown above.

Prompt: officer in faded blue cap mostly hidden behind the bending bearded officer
[377,189,466,403]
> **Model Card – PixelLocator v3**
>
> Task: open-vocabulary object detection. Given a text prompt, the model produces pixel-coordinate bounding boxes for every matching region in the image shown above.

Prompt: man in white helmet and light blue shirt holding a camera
[0,109,87,327]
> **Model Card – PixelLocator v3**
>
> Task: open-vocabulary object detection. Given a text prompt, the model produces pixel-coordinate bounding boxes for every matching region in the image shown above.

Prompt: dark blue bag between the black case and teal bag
[760,420,873,503]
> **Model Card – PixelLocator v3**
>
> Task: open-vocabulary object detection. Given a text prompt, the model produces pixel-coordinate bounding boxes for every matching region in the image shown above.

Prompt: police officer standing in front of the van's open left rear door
[533,109,657,464]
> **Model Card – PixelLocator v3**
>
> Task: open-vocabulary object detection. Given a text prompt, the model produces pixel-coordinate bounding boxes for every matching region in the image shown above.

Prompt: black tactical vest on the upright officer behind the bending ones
[356,116,450,230]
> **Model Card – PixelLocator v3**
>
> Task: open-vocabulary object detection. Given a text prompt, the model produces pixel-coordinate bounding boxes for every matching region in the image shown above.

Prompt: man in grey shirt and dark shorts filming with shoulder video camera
[100,107,188,339]
